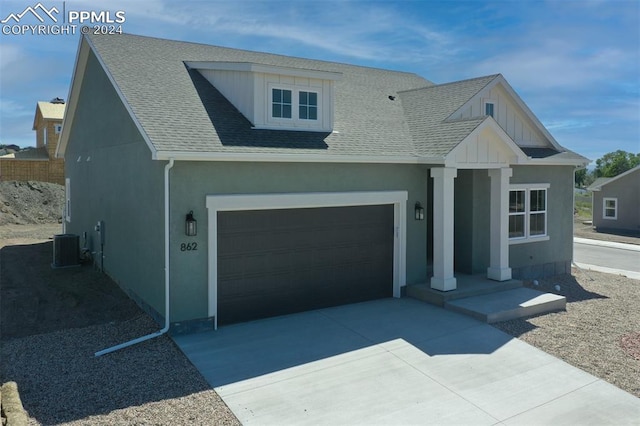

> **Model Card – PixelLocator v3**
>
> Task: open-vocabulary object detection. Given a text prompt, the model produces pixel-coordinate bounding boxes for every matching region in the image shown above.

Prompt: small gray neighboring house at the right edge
[587,166,640,235]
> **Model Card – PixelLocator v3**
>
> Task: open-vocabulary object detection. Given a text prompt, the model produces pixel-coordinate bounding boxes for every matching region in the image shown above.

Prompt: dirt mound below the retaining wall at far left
[0,181,64,225]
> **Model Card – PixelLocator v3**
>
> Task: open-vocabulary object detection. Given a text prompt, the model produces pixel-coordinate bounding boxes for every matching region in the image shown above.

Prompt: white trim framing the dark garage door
[206,191,408,328]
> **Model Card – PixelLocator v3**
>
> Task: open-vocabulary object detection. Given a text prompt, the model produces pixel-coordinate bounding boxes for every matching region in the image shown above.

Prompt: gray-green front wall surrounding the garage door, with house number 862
[171,162,428,321]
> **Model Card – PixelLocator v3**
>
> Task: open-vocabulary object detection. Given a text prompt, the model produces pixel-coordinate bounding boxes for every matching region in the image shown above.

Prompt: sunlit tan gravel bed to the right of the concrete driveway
[493,269,640,398]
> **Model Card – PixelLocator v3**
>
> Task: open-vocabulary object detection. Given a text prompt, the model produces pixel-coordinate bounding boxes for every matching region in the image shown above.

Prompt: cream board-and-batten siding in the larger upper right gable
[451,85,549,148]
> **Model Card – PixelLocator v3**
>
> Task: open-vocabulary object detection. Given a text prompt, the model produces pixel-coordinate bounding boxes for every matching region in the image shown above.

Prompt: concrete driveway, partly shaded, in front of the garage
[174,298,640,425]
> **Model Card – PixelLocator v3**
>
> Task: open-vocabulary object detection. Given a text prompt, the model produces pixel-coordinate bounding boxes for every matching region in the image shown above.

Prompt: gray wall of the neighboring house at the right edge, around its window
[593,170,640,234]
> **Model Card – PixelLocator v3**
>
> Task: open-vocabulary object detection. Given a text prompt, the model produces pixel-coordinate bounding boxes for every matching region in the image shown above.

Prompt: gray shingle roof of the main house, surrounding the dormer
[77,35,584,162]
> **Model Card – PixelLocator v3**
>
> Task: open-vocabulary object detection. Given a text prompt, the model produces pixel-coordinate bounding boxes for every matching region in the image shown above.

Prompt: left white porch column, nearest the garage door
[431,167,458,291]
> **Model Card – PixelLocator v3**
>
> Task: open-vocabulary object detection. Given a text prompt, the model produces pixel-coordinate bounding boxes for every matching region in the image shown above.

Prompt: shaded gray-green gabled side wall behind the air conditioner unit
[65,50,164,320]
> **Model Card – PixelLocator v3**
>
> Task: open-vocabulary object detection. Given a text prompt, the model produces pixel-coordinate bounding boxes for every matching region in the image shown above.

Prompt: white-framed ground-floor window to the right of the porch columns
[509,185,548,240]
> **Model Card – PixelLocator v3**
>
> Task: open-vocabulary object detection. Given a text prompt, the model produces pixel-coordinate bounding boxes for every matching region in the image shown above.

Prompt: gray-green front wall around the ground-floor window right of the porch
[509,166,574,279]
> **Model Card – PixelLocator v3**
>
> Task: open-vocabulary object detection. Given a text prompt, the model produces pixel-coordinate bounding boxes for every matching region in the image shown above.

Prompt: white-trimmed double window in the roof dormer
[269,85,320,124]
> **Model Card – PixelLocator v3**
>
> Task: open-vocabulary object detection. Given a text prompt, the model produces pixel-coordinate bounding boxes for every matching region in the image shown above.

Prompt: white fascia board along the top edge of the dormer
[185,61,342,81]
